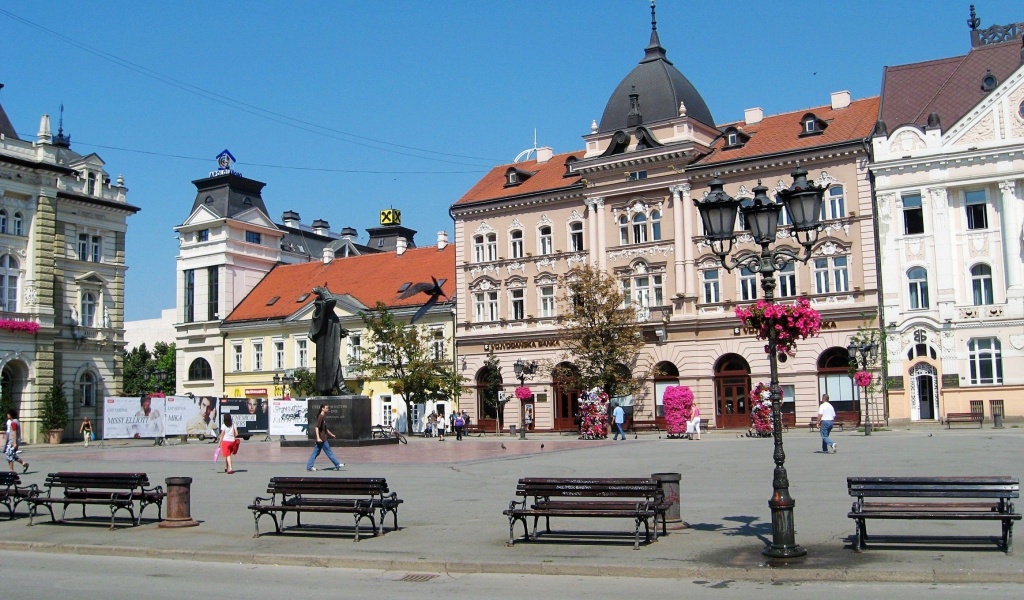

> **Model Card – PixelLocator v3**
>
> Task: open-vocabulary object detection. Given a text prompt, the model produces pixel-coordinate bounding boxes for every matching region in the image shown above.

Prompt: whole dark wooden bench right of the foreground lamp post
[847,476,1021,554]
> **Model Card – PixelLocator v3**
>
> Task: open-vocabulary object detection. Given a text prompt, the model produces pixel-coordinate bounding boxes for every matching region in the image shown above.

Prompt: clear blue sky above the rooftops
[0,0,1024,319]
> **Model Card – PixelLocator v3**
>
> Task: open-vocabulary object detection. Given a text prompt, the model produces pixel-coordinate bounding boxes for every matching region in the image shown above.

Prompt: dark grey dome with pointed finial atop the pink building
[598,0,715,133]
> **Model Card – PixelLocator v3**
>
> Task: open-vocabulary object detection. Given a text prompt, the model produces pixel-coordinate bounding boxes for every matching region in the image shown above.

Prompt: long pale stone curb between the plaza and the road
[0,541,1024,584]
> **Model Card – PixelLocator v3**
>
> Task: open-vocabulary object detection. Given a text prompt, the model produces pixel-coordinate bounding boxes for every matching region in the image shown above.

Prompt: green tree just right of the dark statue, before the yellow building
[349,302,463,431]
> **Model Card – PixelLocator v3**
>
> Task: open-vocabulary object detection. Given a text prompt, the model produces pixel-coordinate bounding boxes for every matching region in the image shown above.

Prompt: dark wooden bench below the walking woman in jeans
[249,477,402,542]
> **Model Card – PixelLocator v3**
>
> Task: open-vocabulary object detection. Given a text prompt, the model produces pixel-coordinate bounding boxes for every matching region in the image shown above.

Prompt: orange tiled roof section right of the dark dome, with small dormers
[693,96,879,167]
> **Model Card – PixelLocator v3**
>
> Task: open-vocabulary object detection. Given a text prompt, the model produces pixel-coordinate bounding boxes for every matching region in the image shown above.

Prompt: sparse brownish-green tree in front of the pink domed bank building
[552,265,646,397]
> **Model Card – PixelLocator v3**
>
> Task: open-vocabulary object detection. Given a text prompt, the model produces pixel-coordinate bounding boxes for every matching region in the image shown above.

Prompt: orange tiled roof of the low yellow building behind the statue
[225,244,456,323]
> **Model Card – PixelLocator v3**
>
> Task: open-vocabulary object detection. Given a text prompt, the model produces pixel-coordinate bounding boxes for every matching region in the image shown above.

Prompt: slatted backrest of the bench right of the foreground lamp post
[846,475,1020,499]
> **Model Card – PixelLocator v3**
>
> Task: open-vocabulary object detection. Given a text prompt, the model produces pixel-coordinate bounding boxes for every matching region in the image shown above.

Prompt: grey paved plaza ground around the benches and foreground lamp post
[0,427,1024,583]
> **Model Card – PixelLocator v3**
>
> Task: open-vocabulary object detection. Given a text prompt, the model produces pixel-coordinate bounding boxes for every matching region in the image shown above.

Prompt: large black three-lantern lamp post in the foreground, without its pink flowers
[693,163,827,559]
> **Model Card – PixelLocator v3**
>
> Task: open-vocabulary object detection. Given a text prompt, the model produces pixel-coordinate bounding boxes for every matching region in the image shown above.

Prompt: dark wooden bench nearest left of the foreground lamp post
[502,477,669,550]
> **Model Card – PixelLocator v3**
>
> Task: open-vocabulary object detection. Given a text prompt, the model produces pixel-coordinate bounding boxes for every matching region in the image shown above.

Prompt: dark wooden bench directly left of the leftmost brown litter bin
[27,472,167,529]
